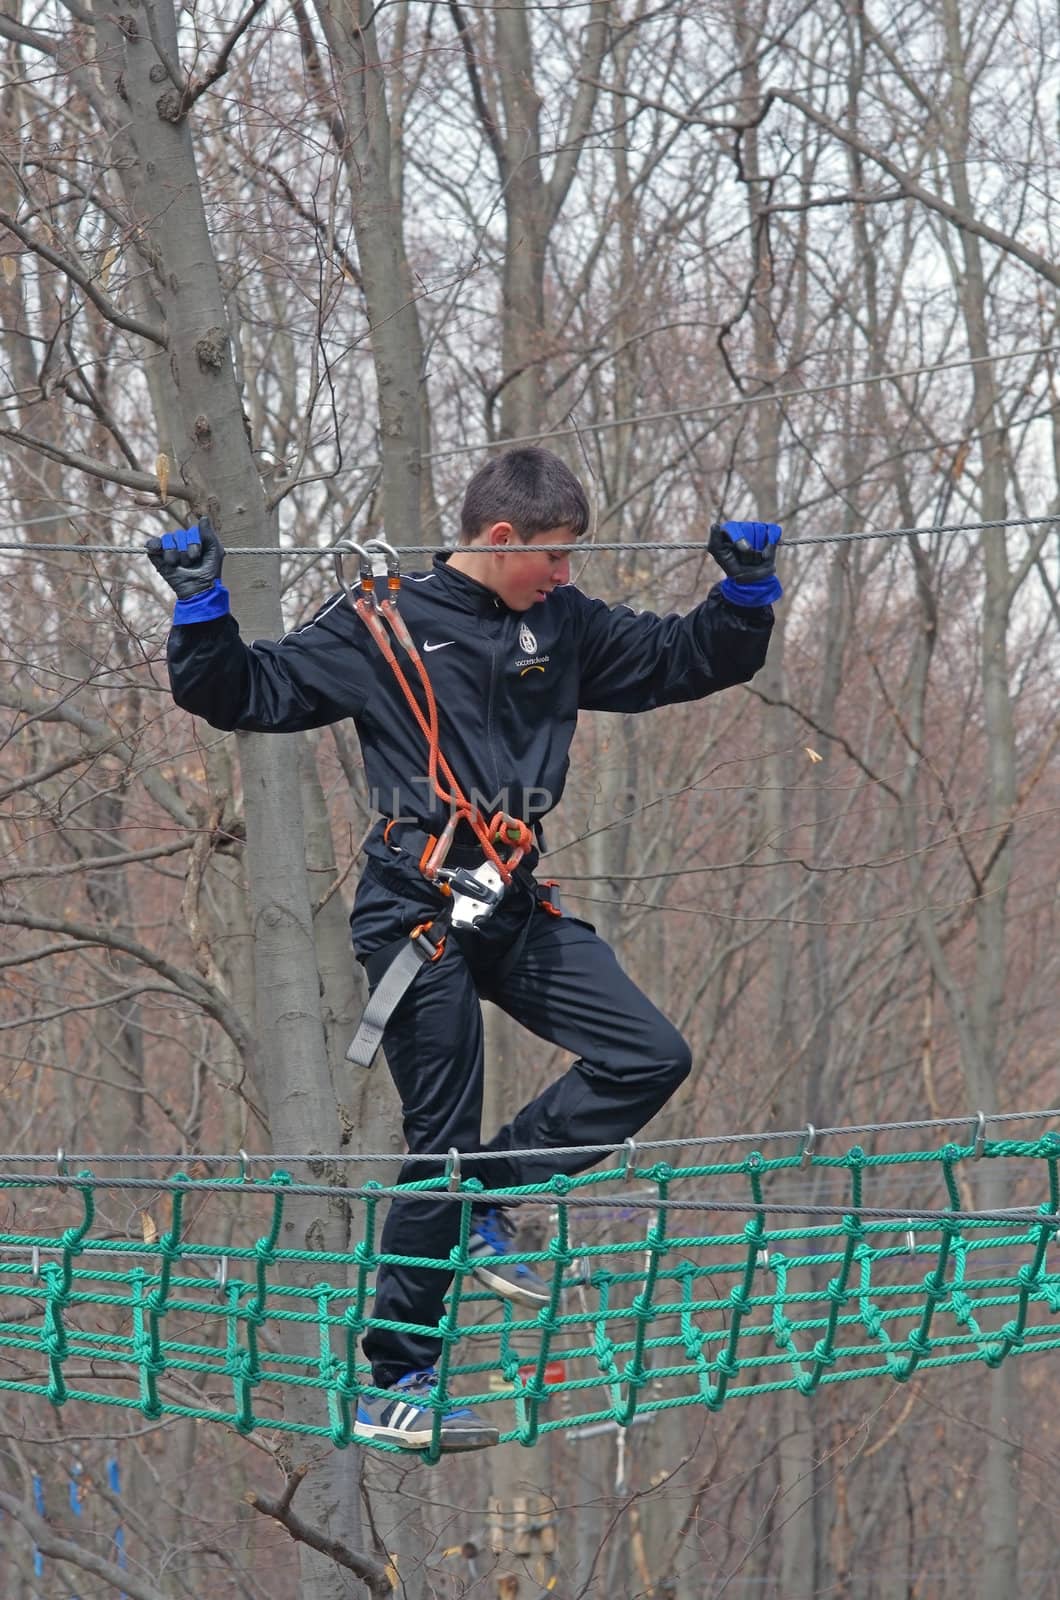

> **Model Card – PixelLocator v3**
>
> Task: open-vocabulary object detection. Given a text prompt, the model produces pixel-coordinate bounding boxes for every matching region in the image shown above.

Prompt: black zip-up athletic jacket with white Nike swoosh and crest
[168,554,773,854]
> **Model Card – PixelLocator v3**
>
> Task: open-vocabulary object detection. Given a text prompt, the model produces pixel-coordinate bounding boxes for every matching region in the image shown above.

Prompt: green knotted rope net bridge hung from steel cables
[0,1112,1060,1459]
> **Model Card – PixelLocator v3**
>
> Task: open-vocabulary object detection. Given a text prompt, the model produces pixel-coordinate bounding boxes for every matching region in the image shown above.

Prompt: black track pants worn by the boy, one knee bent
[365,896,692,1386]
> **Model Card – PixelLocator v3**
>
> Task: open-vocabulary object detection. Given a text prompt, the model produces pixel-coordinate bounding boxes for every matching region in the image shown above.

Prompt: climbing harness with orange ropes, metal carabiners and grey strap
[335,539,547,1067]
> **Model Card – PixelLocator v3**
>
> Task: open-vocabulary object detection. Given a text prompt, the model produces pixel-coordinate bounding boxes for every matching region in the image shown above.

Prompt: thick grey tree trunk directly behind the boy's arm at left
[96,0,371,1600]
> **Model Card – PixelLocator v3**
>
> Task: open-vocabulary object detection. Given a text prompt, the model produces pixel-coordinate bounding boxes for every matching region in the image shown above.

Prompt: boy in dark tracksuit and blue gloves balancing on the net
[147,448,781,1450]
